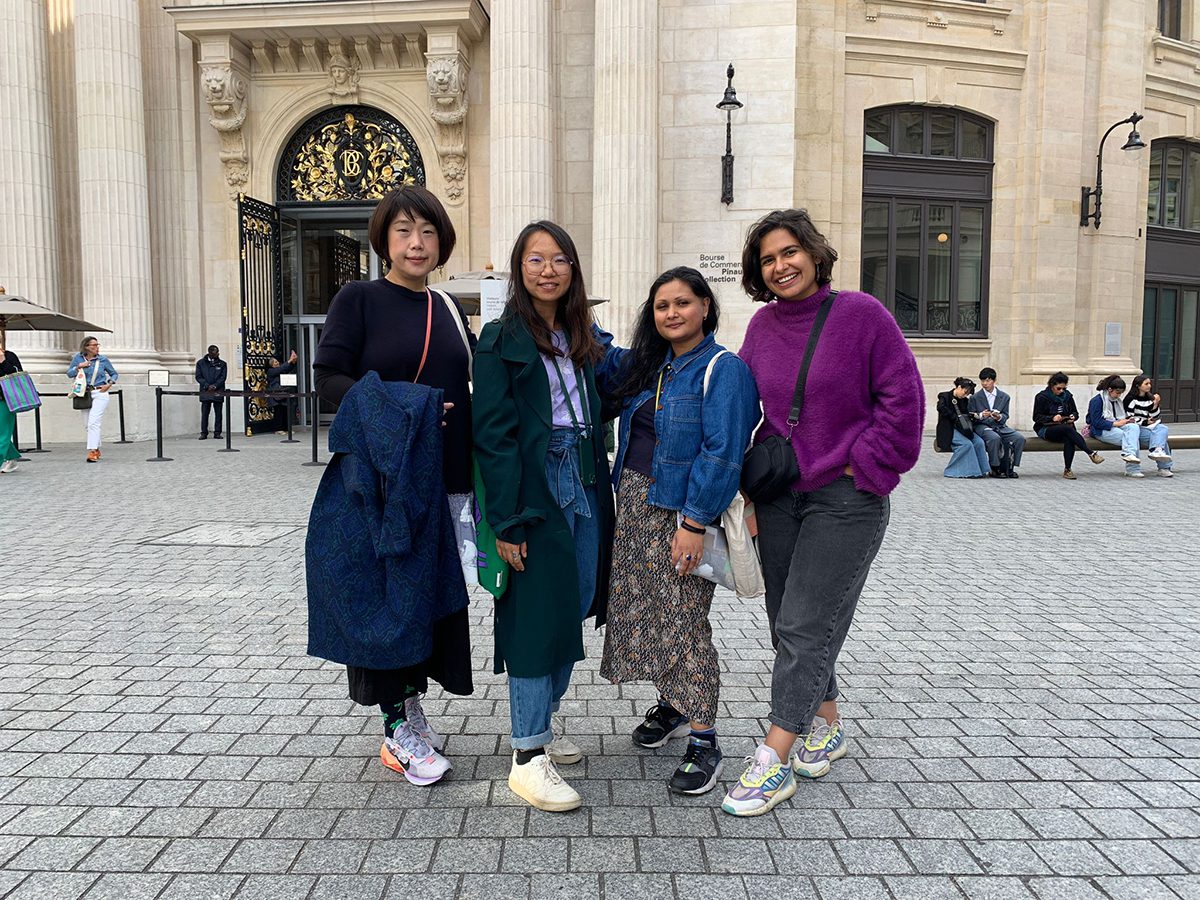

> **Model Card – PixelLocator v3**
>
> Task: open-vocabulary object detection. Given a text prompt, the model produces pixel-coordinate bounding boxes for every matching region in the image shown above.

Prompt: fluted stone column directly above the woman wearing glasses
[490,0,554,270]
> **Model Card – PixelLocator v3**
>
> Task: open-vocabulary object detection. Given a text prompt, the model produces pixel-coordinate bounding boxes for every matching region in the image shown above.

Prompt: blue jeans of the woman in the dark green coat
[509,428,600,750]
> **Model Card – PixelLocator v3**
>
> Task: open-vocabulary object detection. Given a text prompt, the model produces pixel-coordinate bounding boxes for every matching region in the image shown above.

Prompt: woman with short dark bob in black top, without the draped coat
[313,185,475,785]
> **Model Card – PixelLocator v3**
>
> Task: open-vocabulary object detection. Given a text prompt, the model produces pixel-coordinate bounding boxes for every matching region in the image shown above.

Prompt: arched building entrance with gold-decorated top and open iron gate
[238,106,425,433]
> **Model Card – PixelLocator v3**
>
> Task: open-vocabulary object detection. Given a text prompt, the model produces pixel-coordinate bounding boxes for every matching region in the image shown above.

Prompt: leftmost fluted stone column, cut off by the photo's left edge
[0,0,62,355]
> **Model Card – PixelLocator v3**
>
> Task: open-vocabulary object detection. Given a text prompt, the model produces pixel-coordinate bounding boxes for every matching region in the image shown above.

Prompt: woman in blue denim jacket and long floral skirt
[596,266,758,794]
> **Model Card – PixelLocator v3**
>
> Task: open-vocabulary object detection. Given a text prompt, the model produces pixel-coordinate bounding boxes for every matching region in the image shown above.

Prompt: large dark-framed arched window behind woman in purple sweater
[862,106,992,337]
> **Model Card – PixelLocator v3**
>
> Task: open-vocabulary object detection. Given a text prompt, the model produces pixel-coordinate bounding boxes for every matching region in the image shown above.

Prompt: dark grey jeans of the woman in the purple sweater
[757,475,892,734]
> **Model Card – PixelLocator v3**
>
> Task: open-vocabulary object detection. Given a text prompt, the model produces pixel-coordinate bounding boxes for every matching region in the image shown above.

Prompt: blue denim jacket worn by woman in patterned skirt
[595,329,761,524]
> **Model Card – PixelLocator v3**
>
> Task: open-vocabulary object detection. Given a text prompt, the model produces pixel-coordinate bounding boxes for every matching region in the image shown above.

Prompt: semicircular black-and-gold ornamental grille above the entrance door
[278,106,425,203]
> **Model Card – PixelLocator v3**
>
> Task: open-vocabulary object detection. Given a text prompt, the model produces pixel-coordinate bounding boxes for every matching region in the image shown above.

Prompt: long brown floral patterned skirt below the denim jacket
[600,468,721,725]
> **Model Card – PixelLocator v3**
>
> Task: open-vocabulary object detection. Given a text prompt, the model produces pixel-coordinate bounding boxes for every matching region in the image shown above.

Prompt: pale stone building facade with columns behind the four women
[0,0,1200,439]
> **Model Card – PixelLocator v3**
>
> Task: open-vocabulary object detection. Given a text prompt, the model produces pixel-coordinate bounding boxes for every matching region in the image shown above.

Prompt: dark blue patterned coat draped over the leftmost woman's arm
[305,372,467,668]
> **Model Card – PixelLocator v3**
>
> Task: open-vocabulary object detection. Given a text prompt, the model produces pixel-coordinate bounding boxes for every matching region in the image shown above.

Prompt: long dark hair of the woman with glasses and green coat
[500,220,604,366]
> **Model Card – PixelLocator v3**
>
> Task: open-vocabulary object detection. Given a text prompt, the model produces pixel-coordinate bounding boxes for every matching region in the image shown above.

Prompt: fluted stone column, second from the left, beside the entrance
[76,0,157,368]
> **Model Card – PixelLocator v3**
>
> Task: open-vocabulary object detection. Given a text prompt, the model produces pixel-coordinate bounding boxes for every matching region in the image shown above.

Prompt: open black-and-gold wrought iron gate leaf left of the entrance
[238,194,287,436]
